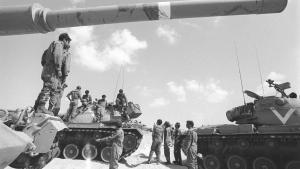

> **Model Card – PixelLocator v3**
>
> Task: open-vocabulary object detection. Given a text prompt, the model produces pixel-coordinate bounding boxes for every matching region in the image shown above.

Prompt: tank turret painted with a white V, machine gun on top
[226,79,300,126]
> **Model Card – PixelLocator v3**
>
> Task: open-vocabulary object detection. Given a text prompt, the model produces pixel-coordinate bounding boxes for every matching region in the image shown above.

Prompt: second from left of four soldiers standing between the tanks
[164,121,172,164]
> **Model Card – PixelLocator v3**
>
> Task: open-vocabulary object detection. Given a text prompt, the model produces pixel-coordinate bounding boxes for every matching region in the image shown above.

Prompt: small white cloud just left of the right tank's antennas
[185,79,229,103]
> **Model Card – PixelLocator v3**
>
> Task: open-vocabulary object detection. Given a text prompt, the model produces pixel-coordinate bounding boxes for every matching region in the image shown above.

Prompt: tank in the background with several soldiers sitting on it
[58,102,143,162]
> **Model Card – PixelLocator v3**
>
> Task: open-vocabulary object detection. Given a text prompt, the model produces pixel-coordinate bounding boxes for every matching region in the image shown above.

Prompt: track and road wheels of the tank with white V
[198,133,300,169]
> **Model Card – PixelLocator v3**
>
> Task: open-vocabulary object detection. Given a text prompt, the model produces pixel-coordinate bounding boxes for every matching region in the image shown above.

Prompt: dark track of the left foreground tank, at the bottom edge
[9,141,59,169]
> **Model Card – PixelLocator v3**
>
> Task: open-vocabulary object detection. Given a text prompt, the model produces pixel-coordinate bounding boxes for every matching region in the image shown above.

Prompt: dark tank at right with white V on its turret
[197,80,300,169]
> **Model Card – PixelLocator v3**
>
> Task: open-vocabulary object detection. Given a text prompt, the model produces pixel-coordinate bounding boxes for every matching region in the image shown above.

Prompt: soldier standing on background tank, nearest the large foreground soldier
[66,86,81,121]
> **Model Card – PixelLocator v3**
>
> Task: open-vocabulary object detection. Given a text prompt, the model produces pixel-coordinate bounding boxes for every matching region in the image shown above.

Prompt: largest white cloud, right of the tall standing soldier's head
[68,27,147,72]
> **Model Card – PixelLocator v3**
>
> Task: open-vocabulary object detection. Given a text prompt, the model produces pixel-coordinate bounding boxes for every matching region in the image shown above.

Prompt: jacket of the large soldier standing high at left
[41,41,71,80]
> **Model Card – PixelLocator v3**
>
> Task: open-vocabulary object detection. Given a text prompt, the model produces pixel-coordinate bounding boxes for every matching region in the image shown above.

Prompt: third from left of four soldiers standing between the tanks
[173,122,182,165]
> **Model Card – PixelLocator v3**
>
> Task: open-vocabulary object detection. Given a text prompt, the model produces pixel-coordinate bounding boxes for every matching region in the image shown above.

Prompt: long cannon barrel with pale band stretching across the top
[0,0,287,35]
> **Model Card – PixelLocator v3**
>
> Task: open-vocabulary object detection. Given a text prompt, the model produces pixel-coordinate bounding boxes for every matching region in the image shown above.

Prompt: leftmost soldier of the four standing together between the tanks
[147,119,164,164]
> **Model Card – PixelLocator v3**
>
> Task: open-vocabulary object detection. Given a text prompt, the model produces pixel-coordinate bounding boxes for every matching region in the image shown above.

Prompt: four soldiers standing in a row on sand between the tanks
[147,119,198,169]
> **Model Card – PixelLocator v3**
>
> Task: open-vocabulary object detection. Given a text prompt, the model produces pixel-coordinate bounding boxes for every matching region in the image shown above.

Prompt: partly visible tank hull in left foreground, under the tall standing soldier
[0,109,66,169]
